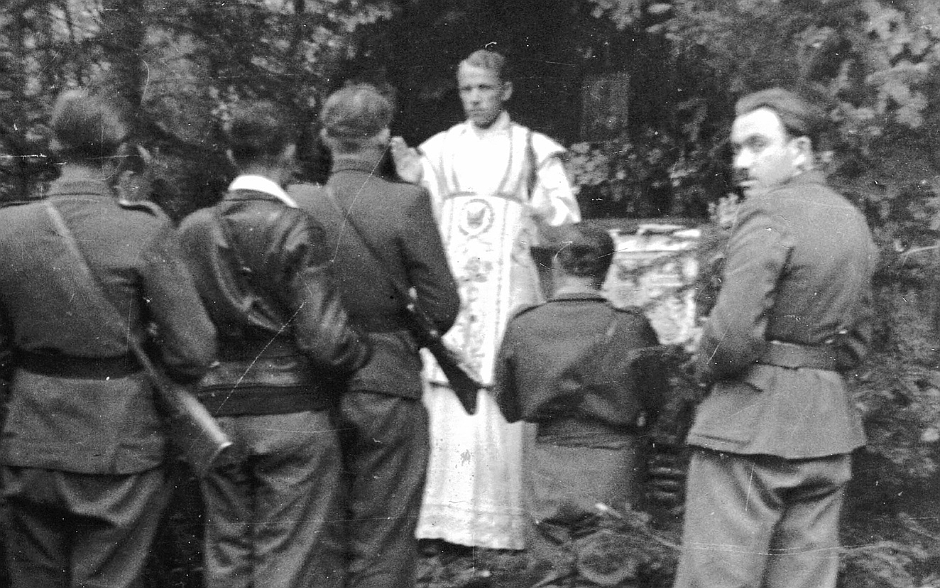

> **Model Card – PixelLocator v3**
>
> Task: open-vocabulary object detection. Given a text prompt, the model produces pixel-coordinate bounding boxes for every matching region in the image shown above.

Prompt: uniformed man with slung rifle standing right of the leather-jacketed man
[290,85,460,588]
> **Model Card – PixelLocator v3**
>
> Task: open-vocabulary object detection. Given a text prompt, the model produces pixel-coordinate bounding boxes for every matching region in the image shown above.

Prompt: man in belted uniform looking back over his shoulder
[675,88,877,588]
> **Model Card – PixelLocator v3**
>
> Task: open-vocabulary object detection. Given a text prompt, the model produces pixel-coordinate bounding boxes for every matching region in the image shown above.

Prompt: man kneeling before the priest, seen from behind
[496,224,666,585]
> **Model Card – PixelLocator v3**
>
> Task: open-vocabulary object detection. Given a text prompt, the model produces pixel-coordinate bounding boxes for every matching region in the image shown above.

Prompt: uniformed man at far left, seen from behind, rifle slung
[0,91,215,588]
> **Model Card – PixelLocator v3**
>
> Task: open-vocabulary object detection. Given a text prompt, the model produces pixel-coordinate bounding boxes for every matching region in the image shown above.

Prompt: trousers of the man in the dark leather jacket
[201,411,343,588]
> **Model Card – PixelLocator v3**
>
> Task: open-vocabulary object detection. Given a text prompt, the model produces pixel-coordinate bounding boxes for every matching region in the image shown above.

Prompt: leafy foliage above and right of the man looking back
[560,9,940,587]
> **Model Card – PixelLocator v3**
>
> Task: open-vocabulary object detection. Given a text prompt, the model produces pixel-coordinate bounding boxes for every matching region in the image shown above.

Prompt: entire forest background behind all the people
[0,0,940,588]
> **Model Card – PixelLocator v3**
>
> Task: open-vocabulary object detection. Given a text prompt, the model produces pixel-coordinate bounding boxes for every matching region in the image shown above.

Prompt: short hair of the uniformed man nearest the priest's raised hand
[320,84,392,153]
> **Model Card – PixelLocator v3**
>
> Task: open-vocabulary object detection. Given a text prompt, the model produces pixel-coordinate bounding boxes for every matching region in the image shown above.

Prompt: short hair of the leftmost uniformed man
[49,89,130,167]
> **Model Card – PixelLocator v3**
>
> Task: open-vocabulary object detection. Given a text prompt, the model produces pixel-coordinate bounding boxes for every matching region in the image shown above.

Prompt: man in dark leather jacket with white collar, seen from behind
[180,103,370,588]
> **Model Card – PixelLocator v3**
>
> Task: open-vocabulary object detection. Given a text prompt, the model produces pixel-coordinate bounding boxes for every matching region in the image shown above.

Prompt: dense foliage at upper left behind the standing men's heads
[0,0,392,218]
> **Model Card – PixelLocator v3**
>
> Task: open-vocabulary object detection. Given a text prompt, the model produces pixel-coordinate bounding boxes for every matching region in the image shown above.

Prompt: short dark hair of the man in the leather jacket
[228,101,298,166]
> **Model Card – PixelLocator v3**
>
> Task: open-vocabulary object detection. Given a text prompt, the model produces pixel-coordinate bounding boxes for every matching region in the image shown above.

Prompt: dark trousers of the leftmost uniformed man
[2,467,167,588]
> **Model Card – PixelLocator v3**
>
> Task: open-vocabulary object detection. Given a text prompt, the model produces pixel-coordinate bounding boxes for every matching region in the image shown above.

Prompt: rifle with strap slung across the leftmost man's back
[45,200,234,476]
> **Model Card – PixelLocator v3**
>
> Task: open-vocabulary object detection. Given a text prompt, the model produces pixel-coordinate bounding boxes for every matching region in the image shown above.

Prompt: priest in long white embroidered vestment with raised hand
[392,50,581,549]
